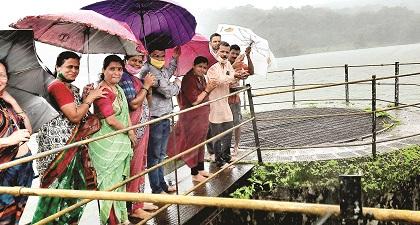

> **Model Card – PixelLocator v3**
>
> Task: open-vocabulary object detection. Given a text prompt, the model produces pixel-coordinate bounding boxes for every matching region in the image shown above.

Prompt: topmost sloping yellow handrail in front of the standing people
[0,87,249,170]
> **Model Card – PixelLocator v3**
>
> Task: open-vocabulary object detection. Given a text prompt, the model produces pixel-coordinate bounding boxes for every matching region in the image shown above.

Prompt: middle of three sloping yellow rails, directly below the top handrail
[34,117,255,225]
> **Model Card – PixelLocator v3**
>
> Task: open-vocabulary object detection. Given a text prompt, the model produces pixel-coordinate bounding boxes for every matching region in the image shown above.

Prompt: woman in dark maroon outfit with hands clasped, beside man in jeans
[167,56,216,182]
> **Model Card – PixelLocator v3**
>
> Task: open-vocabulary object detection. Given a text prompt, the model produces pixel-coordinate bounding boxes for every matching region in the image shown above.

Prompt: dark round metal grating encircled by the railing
[241,108,389,147]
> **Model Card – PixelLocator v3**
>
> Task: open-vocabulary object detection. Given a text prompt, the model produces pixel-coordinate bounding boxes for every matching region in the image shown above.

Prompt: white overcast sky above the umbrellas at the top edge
[0,0,333,29]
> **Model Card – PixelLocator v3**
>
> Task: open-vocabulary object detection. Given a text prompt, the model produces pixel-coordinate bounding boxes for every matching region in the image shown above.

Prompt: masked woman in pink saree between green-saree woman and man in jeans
[119,54,157,219]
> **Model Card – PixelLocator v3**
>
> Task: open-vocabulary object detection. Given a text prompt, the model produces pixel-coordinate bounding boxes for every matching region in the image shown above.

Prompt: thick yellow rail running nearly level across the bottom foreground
[0,187,420,223]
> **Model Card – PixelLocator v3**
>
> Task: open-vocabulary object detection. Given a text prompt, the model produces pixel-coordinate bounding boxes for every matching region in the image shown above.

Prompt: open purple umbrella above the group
[82,0,197,49]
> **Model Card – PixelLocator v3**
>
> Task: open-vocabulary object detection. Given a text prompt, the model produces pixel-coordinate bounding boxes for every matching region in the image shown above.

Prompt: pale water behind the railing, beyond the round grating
[248,44,420,111]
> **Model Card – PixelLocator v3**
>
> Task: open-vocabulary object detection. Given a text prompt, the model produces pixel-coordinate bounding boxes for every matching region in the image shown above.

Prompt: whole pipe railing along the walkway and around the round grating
[0,60,420,224]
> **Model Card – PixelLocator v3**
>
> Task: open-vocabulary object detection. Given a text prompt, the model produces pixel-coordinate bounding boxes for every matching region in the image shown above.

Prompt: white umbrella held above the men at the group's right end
[216,24,274,75]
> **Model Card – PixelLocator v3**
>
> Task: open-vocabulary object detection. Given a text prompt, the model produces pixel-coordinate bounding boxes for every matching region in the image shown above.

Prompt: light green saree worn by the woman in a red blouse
[89,86,133,224]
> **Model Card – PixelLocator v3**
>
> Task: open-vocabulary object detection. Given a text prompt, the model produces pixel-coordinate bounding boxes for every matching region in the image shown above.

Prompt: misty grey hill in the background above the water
[196,5,420,57]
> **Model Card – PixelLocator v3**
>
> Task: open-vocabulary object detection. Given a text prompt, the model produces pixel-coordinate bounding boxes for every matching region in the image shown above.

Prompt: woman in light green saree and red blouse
[89,55,137,224]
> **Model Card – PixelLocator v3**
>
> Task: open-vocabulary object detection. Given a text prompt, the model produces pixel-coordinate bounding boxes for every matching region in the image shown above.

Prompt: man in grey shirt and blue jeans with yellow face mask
[140,43,181,194]
